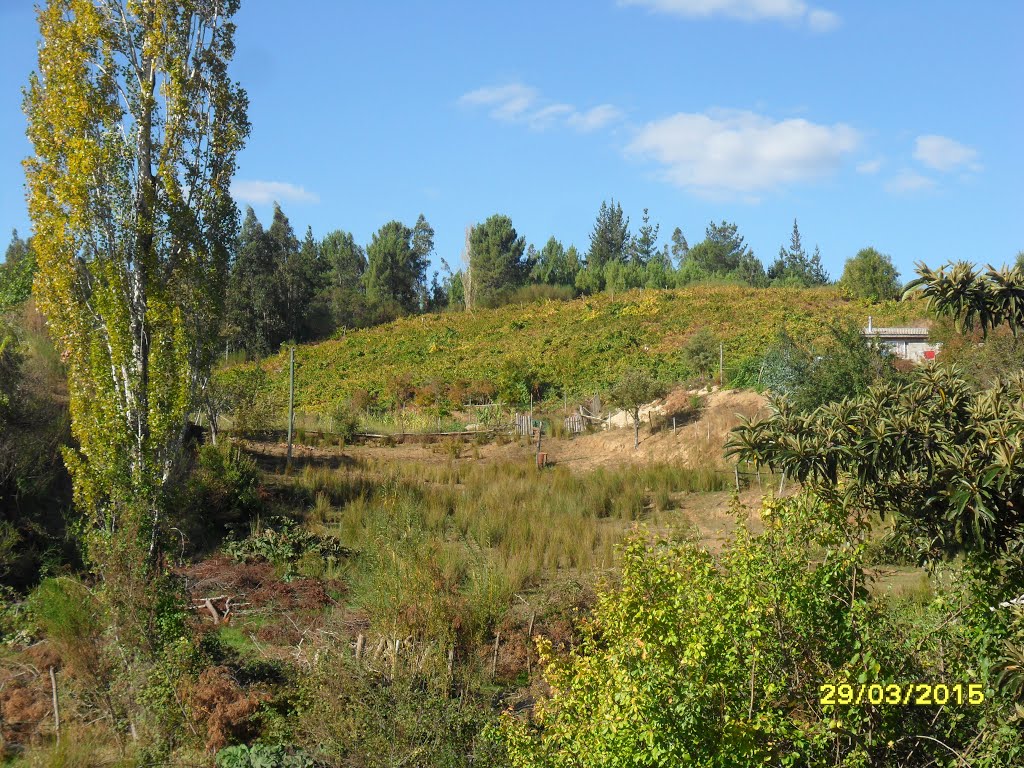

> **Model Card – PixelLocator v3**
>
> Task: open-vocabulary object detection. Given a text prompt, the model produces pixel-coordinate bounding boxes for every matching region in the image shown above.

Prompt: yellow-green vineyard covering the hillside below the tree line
[226,286,926,413]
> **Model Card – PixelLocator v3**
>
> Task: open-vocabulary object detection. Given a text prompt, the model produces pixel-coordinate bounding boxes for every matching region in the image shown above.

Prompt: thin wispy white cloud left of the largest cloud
[459,83,623,133]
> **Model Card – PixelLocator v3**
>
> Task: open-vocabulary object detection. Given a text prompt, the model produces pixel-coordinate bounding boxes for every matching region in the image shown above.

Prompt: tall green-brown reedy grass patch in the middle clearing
[288,462,731,645]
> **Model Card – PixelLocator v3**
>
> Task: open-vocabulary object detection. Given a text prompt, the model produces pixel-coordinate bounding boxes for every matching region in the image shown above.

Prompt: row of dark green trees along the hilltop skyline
[0,200,913,356]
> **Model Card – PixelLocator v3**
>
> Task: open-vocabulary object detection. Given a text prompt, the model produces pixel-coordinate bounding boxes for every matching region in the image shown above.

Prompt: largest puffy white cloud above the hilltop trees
[627,111,860,196]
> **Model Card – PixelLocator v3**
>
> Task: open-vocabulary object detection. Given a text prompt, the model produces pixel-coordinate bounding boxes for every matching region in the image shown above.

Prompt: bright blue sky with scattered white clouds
[0,0,1024,279]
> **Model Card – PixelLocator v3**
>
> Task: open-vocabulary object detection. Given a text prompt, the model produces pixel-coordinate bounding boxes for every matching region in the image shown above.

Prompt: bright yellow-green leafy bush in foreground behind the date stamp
[492,497,1022,768]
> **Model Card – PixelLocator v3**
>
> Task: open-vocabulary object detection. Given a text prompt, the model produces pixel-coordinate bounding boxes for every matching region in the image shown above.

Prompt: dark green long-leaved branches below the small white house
[729,368,1024,555]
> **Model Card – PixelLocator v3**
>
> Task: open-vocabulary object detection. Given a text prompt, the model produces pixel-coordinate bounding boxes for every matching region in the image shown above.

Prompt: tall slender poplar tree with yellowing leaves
[25,0,249,573]
